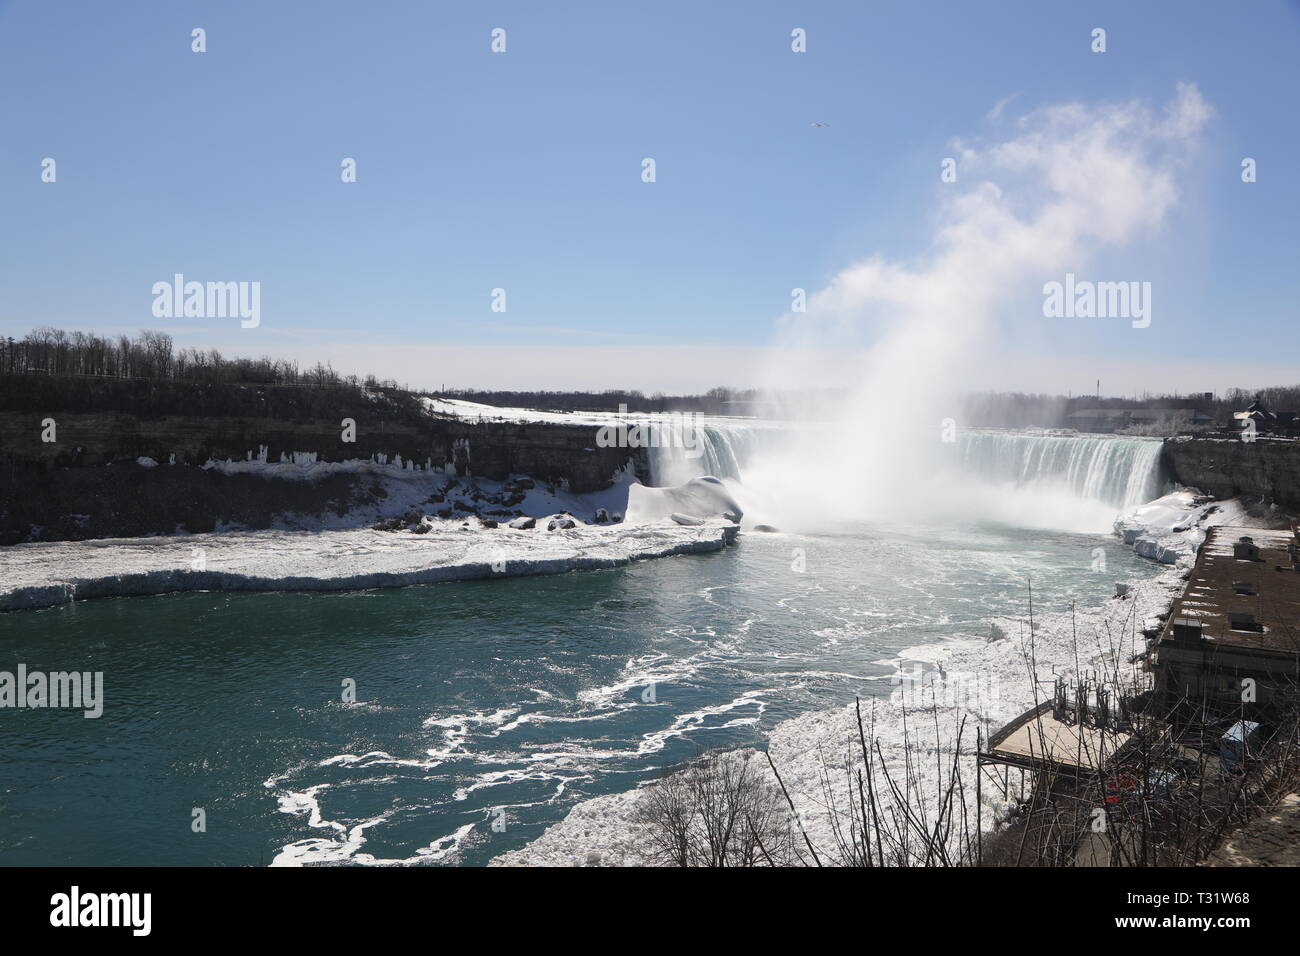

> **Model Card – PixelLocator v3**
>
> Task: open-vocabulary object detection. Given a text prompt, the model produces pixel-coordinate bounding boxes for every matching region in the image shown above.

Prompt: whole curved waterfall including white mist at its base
[650,424,1164,533]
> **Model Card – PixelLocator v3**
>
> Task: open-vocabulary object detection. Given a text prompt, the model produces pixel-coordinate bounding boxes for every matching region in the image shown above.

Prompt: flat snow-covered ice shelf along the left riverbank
[0,519,737,610]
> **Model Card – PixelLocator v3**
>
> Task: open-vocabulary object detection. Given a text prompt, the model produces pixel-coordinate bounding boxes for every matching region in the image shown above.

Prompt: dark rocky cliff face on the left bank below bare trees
[0,407,649,544]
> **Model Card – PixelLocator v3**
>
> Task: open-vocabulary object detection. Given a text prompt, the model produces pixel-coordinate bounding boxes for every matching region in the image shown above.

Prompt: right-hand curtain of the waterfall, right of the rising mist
[957,431,1162,507]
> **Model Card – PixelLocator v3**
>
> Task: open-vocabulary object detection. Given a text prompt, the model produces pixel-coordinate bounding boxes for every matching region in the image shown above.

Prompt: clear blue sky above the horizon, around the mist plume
[0,0,1300,392]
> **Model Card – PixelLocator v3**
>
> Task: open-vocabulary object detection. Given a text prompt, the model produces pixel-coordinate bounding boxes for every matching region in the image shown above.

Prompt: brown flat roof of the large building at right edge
[1162,524,1300,652]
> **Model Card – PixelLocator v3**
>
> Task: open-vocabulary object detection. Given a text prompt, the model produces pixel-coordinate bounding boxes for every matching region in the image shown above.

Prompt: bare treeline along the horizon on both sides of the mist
[0,328,1300,428]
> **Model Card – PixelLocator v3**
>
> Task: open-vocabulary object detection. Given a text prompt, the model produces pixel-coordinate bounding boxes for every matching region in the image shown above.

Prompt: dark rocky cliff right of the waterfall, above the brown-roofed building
[1164,437,1300,512]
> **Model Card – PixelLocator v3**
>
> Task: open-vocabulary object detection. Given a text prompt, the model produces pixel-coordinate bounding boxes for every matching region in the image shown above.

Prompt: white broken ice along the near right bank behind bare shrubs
[491,494,1236,865]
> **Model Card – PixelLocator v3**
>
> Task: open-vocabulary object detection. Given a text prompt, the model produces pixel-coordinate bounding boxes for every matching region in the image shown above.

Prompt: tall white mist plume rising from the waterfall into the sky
[742,85,1210,531]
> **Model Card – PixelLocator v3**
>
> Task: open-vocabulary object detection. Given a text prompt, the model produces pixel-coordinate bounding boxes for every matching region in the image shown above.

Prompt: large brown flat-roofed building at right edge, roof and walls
[1151,525,1300,722]
